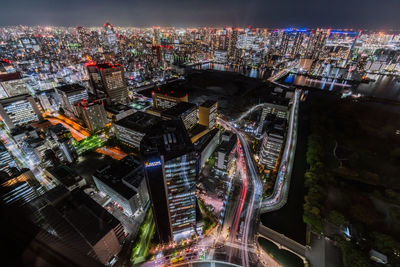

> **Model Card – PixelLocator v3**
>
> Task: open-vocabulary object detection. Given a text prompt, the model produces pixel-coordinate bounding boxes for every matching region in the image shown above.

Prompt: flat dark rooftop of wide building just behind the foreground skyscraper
[115,111,161,133]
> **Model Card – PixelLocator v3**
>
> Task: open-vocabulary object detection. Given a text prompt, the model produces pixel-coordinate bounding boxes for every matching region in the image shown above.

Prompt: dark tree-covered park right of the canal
[303,93,400,266]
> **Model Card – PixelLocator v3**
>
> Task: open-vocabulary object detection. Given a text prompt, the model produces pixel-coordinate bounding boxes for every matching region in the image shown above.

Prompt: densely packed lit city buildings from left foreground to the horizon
[0,23,400,266]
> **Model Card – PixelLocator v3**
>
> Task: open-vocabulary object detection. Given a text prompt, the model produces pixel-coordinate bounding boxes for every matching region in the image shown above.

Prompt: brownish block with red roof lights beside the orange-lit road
[75,99,109,132]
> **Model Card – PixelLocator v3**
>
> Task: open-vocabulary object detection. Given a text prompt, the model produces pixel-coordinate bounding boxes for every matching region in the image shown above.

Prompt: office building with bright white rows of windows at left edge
[0,95,42,130]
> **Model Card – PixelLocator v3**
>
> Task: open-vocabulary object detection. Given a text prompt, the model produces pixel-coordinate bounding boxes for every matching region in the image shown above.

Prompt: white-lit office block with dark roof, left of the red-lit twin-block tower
[55,84,88,117]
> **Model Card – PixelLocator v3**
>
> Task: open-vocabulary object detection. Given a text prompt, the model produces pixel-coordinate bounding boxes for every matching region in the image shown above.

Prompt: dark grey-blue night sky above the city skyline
[0,0,400,29]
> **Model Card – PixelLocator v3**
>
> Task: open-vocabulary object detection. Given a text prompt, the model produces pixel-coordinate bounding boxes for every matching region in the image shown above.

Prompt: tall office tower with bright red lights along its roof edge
[86,63,129,104]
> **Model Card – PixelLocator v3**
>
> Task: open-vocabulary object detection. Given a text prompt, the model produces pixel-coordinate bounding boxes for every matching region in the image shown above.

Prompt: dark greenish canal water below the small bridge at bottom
[258,238,304,267]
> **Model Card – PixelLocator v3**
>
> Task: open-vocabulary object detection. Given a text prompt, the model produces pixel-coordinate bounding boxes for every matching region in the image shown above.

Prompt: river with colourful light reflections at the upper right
[280,73,400,101]
